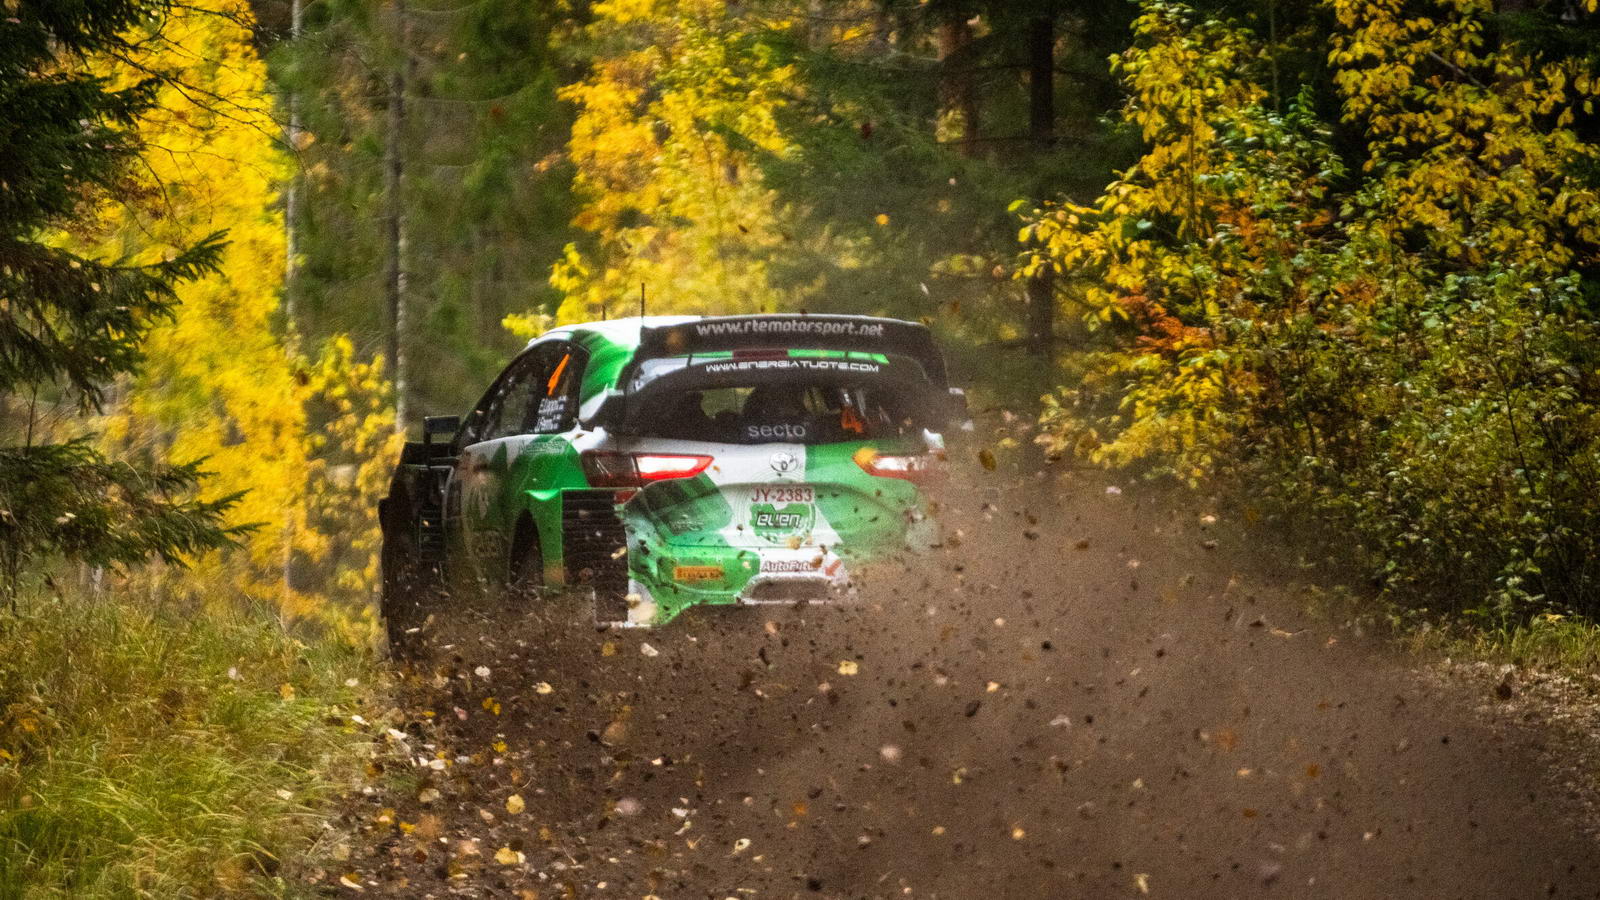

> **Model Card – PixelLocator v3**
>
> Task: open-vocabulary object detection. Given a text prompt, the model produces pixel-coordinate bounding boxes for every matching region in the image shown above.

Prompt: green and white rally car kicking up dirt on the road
[379,315,966,639]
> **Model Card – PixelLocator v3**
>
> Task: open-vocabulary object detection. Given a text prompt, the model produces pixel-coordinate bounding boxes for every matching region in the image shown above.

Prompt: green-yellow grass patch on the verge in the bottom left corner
[0,586,370,900]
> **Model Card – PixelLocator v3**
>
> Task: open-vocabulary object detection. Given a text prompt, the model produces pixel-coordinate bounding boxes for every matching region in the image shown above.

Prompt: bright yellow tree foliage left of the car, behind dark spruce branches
[69,0,398,620]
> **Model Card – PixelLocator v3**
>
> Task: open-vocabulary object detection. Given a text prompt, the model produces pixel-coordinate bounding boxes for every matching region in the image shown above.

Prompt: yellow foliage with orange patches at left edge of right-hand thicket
[1018,8,1267,477]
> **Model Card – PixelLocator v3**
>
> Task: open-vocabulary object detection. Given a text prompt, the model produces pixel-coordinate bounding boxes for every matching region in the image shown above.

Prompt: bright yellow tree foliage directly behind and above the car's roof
[550,0,795,322]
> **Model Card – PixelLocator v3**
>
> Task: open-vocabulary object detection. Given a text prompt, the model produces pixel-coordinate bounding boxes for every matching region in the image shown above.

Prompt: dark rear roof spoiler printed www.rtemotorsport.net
[618,314,949,391]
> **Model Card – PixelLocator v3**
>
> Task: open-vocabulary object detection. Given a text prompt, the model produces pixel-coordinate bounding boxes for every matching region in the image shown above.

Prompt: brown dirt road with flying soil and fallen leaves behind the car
[315,479,1600,900]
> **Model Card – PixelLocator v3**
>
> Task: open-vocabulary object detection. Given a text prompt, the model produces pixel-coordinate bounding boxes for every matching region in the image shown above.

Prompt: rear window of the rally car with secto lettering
[640,383,922,444]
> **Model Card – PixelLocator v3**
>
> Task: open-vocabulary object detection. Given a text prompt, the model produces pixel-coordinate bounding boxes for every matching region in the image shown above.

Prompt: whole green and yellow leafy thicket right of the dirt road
[1021,0,1600,623]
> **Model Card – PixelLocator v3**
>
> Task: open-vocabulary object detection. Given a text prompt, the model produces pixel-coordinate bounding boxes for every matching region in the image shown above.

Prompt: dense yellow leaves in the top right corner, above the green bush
[1328,0,1600,274]
